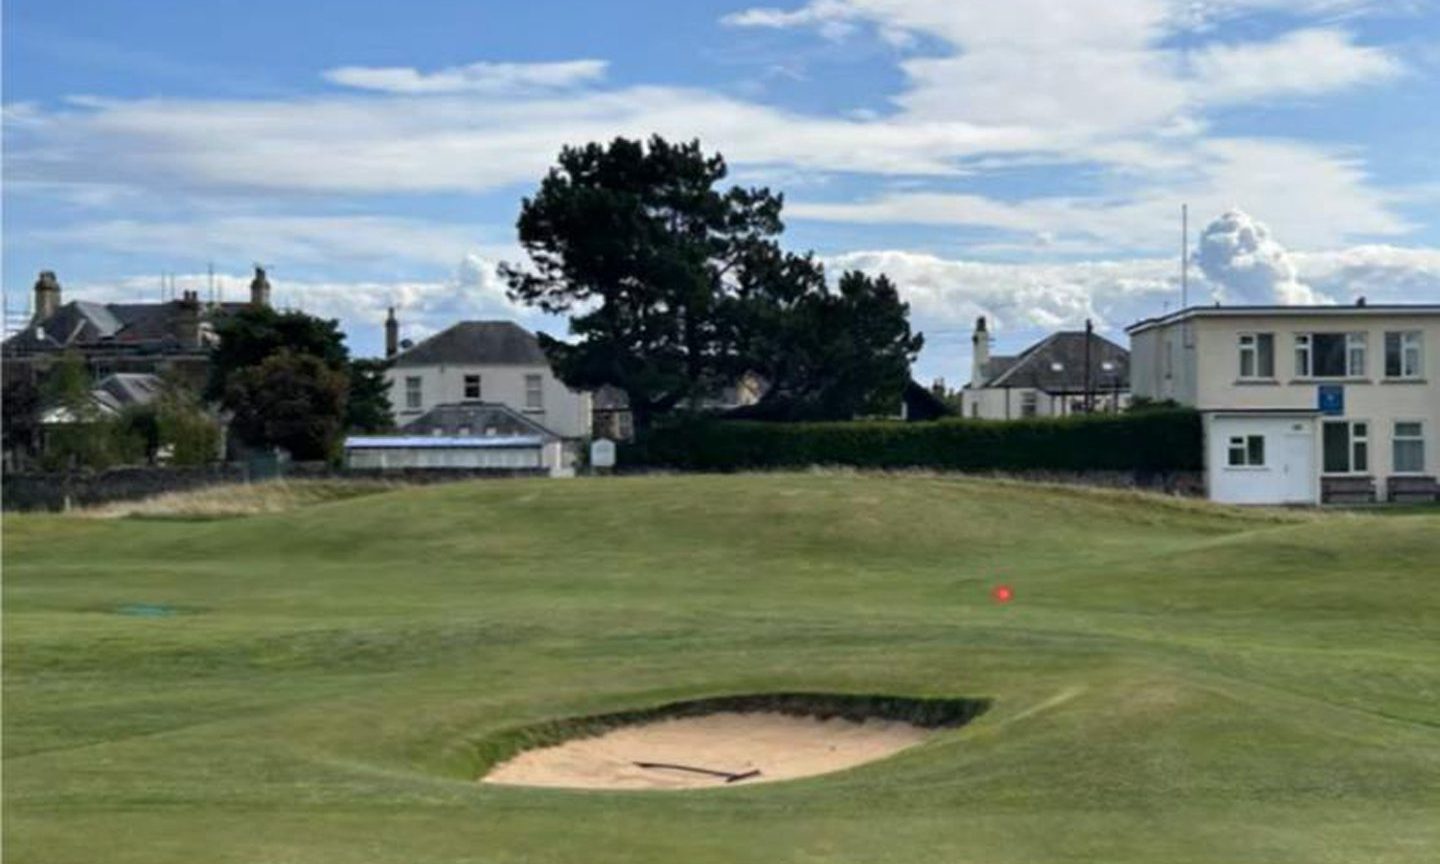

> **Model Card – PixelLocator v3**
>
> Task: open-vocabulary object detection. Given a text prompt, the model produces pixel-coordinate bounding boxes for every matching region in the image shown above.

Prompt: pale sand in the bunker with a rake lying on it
[482,711,935,789]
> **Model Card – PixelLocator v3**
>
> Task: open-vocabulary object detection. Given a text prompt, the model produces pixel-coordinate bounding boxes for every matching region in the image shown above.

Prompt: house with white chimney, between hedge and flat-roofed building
[960,315,1130,420]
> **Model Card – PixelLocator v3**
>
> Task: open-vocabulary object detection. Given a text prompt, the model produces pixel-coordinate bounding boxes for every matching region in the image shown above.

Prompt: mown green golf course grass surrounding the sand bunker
[3,474,1440,864]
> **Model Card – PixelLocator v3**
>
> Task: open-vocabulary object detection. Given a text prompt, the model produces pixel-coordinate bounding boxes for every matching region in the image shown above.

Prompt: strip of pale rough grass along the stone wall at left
[81,480,400,518]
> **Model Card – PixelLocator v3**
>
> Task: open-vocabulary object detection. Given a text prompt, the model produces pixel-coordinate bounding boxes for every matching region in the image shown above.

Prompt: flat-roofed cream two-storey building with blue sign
[1128,300,1440,504]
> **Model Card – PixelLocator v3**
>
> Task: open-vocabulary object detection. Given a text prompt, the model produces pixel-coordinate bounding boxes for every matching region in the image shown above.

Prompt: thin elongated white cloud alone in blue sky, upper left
[324,60,609,95]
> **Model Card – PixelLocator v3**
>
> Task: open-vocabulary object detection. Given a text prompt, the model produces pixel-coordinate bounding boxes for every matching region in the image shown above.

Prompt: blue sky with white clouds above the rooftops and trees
[3,0,1440,387]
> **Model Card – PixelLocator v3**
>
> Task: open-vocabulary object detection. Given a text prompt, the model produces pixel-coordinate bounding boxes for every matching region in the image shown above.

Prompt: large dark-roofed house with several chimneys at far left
[0,268,271,387]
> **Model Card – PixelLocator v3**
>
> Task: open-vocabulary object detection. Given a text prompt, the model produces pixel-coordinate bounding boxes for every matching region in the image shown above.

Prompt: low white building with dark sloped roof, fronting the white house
[344,402,573,477]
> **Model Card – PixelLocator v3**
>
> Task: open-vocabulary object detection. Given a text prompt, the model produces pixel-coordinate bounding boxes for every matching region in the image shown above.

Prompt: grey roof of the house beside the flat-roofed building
[981,330,1130,393]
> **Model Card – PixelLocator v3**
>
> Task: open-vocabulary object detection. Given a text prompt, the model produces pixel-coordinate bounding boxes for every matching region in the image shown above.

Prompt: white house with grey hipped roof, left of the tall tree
[386,321,590,444]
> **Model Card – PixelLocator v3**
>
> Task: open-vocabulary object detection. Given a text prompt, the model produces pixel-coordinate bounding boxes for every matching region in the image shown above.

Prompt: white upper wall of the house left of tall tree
[384,366,590,438]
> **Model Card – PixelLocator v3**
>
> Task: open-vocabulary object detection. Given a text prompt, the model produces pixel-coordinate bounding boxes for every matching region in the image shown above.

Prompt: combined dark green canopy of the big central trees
[501,137,920,428]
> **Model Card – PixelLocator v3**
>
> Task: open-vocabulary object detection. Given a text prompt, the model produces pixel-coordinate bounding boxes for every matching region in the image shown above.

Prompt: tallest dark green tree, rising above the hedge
[501,137,782,428]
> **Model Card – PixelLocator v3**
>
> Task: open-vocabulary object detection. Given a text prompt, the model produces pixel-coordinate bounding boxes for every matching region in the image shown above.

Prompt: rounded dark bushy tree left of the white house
[225,348,350,461]
